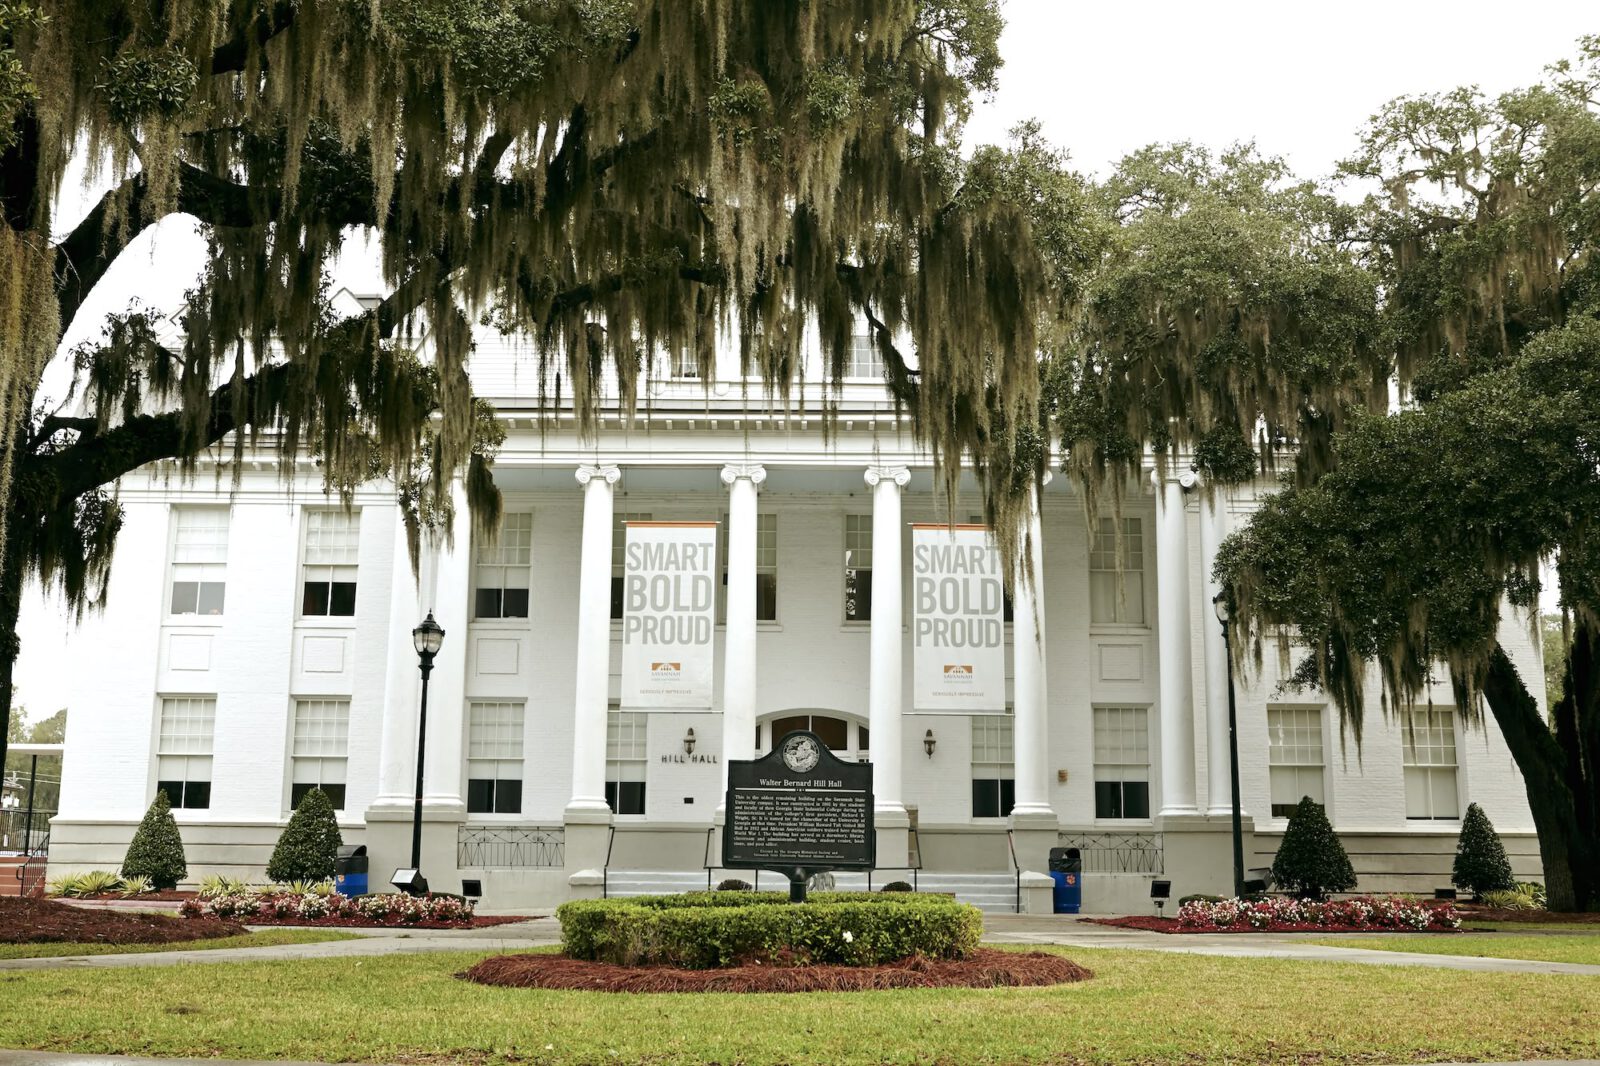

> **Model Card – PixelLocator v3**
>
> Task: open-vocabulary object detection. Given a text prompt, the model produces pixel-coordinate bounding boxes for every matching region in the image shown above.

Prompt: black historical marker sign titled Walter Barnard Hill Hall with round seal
[722,730,877,884]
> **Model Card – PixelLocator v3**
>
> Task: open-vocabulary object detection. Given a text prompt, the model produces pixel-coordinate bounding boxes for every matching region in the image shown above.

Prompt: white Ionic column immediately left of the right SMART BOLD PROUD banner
[866,466,910,869]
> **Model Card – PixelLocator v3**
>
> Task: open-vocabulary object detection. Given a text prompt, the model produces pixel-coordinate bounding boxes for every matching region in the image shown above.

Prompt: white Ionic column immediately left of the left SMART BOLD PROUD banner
[566,466,622,816]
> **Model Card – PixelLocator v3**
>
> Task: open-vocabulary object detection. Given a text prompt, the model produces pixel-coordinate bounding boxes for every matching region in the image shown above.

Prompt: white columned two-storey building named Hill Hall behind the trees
[51,328,1542,911]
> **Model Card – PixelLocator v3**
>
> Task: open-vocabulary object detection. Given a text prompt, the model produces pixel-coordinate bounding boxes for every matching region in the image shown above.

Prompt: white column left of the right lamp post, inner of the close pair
[1154,472,1197,818]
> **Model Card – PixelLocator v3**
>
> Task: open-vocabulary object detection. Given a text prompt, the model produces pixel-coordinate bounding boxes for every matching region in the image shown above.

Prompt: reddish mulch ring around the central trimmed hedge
[456,948,1094,992]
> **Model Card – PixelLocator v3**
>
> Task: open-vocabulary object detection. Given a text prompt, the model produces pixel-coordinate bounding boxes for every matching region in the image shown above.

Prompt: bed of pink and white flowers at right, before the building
[1178,896,1461,933]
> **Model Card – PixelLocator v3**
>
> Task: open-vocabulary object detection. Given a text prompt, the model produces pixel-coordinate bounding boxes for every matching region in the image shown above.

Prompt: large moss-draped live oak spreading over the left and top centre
[0,0,1051,765]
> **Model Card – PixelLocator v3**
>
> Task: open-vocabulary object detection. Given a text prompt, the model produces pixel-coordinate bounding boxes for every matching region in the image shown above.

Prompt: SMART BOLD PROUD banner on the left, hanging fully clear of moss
[622,522,717,711]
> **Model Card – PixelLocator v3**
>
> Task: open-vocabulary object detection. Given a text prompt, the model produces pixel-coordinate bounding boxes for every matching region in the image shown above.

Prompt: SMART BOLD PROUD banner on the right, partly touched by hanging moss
[910,525,1005,714]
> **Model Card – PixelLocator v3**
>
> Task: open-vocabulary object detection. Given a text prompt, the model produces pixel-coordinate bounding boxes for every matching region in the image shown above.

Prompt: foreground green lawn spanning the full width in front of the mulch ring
[0,949,1600,1066]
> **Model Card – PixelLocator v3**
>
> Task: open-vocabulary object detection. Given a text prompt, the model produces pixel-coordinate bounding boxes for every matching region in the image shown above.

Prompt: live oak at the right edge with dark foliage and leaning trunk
[1218,38,1600,911]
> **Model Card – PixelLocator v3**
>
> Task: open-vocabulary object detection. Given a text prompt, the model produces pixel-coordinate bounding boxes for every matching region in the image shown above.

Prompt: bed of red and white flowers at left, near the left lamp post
[178,892,523,928]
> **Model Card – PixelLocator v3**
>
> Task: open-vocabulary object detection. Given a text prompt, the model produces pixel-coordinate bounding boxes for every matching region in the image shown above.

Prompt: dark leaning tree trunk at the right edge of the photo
[1483,642,1597,911]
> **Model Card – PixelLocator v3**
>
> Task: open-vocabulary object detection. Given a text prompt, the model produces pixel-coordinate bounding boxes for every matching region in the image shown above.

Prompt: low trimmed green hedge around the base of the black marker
[555,892,982,970]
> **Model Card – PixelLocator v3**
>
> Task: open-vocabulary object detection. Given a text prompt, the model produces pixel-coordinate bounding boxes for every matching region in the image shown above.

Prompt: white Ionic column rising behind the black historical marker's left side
[717,463,766,800]
